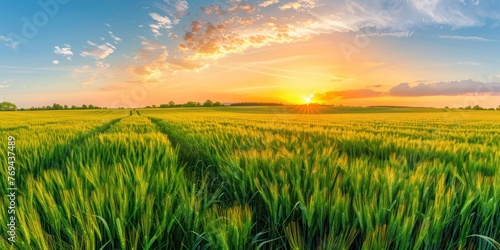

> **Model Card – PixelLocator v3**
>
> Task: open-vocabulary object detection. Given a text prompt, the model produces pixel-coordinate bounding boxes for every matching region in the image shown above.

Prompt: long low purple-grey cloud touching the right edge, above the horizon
[389,79,500,96]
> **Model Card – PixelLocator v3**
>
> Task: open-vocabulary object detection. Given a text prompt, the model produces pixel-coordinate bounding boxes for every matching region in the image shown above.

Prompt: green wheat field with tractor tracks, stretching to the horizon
[0,107,500,250]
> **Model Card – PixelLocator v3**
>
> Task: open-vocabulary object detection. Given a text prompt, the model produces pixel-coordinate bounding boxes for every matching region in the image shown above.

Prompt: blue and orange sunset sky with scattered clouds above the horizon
[0,0,500,108]
